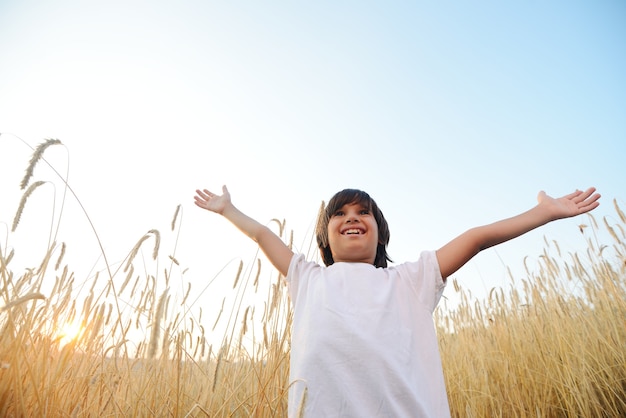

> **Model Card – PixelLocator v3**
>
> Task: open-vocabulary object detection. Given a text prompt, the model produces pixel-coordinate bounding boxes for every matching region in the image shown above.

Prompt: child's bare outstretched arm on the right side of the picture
[437,187,600,280]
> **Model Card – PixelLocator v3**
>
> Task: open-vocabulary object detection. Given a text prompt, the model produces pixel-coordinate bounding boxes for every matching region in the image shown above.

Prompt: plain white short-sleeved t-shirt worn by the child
[286,251,450,418]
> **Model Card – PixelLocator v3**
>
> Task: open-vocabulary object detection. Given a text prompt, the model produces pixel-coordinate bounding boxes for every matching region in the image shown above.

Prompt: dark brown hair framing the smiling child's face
[315,189,392,267]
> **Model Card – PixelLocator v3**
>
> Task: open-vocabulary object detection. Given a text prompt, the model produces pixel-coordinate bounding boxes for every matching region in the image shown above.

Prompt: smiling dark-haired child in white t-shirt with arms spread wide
[195,186,600,418]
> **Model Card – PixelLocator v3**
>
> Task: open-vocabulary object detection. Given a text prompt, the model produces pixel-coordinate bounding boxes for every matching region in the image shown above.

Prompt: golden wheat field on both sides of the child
[0,140,626,417]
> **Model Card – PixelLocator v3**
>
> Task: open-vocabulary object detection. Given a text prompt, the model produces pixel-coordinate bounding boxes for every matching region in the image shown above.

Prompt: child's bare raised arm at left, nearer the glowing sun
[194,186,293,276]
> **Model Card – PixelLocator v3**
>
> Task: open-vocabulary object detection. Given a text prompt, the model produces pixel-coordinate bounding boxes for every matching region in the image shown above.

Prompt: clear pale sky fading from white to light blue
[0,0,626,334]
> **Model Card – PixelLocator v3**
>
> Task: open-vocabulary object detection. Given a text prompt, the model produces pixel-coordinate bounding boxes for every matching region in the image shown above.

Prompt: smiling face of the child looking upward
[328,203,378,264]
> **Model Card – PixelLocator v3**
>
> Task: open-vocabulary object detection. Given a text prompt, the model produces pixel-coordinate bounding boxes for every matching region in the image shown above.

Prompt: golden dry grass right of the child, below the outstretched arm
[437,205,626,417]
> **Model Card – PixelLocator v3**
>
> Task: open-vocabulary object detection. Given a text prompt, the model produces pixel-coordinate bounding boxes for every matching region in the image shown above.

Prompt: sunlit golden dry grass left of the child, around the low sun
[0,230,291,417]
